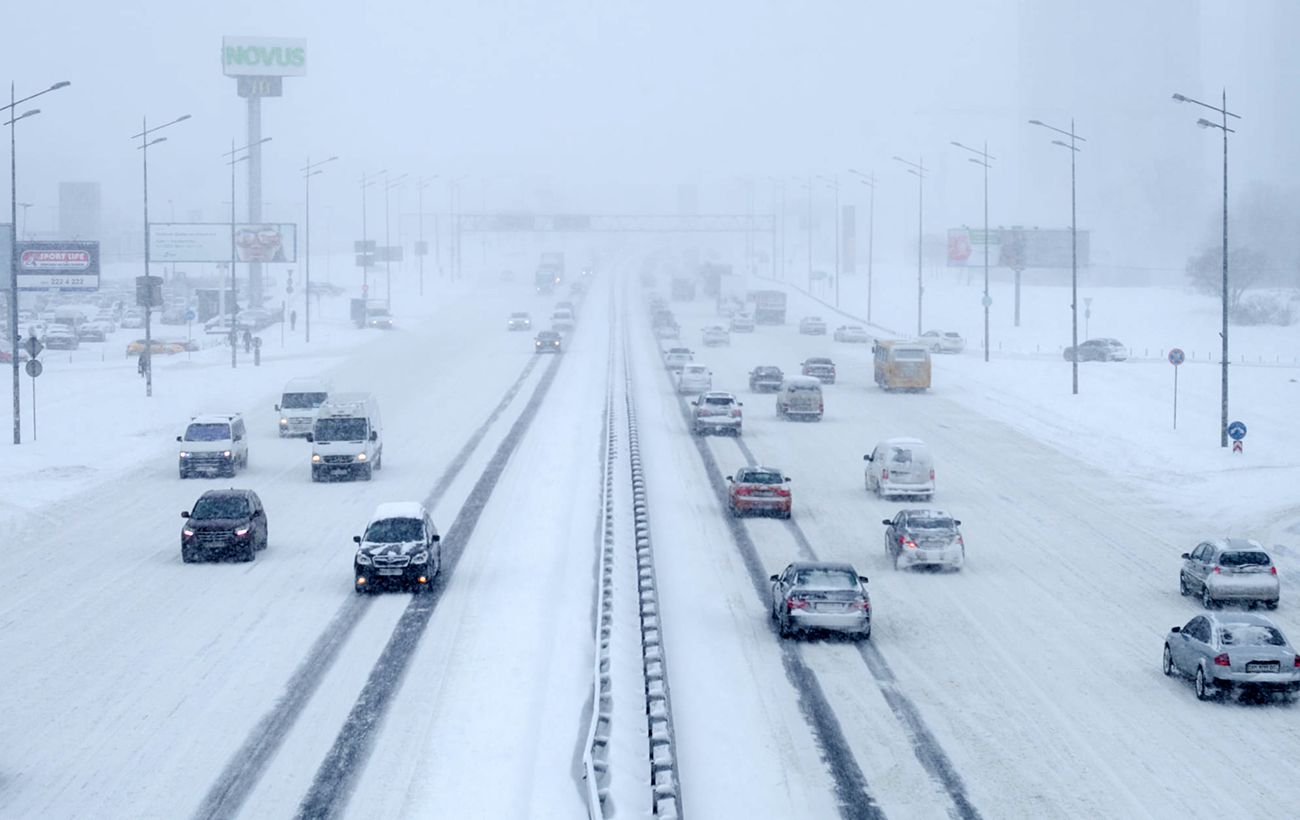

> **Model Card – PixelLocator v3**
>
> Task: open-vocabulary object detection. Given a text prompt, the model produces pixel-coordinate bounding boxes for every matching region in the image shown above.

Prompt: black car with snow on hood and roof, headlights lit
[352,502,442,593]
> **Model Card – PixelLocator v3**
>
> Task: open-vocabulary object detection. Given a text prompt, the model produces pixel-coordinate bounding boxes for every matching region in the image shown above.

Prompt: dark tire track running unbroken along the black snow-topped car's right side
[295,356,560,820]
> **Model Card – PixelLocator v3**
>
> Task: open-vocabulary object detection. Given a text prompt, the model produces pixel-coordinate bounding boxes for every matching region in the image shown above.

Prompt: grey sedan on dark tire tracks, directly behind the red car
[771,561,871,638]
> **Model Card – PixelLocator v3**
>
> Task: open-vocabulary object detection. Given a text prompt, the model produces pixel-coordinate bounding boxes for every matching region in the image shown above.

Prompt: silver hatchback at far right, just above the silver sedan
[1178,538,1282,609]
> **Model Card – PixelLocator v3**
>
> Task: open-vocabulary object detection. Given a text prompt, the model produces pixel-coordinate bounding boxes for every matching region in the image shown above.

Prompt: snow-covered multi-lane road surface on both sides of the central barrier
[0,269,1300,817]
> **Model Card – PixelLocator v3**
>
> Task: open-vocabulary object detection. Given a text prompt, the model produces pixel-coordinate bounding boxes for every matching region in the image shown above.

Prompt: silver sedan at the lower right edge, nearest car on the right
[1162,612,1300,700]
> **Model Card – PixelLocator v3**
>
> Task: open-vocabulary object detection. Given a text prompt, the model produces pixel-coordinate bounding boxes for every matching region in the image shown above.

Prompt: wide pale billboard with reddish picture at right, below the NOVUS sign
[150,222,298,263]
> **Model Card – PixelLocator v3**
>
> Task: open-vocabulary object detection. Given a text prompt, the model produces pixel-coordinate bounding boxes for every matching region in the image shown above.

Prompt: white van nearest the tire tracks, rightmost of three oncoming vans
[307,392,384,481]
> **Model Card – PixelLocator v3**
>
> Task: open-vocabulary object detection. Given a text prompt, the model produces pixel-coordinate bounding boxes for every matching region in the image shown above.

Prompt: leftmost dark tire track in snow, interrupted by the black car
[194,356,540,820]
